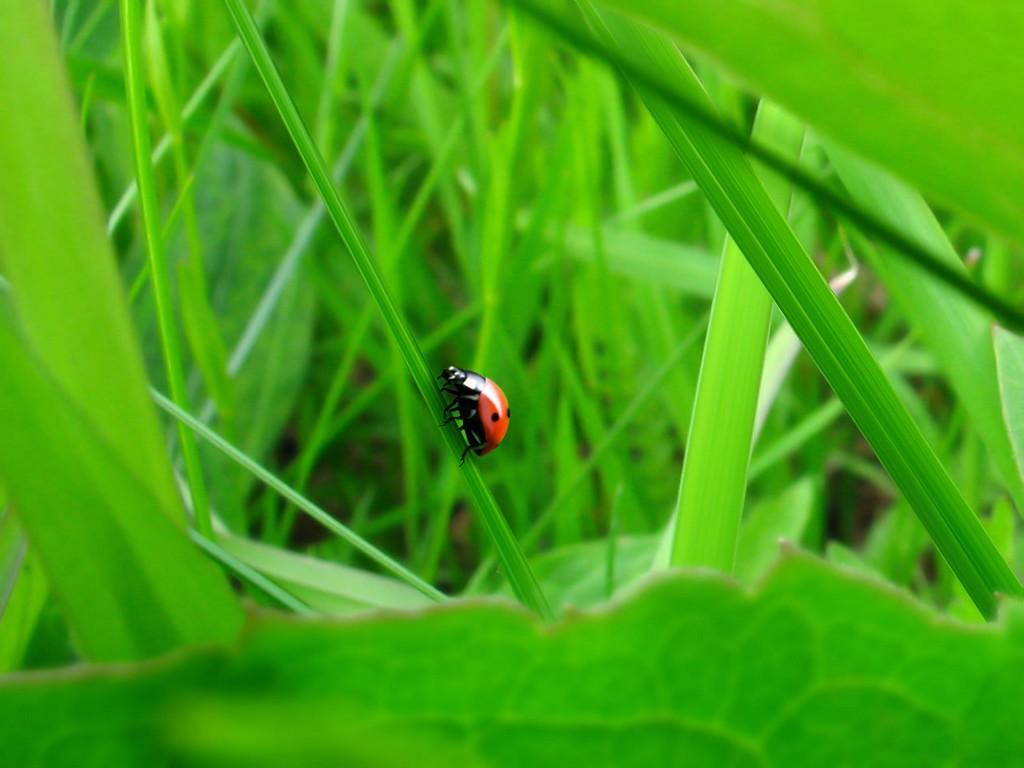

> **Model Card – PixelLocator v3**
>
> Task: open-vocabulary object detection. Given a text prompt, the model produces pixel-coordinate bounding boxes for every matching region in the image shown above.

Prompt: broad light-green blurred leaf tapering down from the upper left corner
[0,2,178,524]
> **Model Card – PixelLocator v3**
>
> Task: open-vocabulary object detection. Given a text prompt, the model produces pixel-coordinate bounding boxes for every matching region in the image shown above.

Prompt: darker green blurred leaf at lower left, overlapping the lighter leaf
[0,304,243,660]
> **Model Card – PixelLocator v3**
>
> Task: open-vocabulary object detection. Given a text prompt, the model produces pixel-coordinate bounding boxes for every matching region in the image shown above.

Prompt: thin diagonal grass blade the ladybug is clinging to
[219,0,551,616]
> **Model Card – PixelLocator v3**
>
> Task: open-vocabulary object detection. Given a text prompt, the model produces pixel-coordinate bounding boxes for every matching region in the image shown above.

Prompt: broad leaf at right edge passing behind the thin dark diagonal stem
[828,147,1024,510]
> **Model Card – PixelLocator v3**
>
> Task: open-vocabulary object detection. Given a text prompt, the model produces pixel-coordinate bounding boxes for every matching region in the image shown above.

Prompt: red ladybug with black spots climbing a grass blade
[437,366,511,466]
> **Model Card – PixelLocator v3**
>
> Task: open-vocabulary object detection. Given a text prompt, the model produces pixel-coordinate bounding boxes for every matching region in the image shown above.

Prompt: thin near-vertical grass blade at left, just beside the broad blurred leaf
[121,0,213,537]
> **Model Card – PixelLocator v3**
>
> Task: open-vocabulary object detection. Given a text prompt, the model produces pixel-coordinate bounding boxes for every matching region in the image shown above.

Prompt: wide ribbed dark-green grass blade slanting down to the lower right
[589,3,1022,617]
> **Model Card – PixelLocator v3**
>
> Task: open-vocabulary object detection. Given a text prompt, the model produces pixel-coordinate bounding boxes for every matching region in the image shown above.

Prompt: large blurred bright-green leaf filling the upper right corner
[603,0,1024,249]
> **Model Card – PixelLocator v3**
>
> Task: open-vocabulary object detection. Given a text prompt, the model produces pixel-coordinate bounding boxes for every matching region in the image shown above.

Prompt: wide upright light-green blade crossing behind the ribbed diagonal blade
[672,101,804,573]
